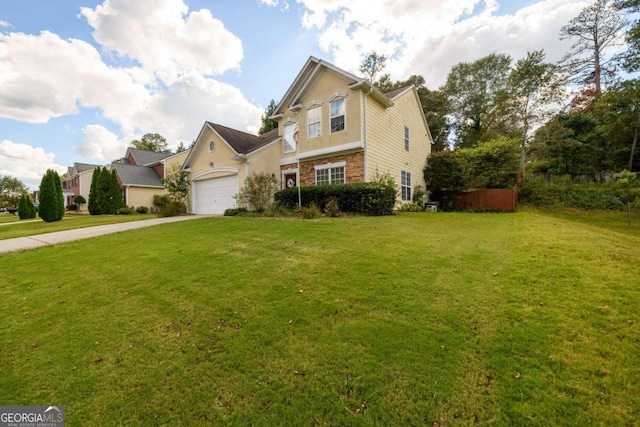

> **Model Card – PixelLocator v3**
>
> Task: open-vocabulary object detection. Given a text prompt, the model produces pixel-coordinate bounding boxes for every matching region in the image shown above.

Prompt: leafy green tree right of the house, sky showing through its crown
[441,53,511,148]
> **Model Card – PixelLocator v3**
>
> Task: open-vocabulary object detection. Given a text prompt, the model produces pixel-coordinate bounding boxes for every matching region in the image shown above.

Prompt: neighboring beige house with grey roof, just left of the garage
[111,147,189,209]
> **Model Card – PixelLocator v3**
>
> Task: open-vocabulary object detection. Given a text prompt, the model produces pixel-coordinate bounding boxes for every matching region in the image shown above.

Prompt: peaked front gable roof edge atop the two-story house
[271,56,393,118]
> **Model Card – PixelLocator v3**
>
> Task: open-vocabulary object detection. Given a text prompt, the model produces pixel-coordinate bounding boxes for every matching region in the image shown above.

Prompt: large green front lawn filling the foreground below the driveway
[0,211,640,426]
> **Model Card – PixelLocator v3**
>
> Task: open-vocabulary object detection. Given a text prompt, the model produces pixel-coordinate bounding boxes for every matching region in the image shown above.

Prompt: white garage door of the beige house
[193,175,238,214]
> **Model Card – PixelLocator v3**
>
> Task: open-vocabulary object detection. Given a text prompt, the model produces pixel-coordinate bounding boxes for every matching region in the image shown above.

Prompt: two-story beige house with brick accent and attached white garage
[183,57,432,213]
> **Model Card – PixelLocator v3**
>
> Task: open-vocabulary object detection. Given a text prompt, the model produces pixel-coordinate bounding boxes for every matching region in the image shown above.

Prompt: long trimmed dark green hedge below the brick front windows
[274,182,396,215]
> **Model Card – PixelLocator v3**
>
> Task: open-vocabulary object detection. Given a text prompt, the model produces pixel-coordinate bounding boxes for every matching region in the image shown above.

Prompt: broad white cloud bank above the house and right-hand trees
[298,0,587,89]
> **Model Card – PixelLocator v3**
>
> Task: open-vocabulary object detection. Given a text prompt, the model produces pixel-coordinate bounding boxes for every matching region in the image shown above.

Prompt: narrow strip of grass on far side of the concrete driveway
[0,214,157,240]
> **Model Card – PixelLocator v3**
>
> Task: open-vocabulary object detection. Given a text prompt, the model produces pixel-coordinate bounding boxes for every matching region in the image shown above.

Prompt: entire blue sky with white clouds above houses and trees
[0,0,587,189]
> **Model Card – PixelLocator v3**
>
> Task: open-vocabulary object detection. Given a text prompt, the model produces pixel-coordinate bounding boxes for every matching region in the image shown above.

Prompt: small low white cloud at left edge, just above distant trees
[0,139,67,190]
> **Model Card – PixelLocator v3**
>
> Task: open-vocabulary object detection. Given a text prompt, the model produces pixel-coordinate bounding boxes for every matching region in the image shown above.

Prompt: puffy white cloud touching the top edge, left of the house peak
[80,0,243,84]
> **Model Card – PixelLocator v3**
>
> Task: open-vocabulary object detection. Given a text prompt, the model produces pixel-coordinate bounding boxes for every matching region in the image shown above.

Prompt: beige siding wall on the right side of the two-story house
[365,89,431,193]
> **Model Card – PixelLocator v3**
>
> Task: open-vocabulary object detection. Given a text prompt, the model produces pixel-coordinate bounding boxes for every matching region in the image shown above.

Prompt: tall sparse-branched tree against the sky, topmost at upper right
[559,0,626,99]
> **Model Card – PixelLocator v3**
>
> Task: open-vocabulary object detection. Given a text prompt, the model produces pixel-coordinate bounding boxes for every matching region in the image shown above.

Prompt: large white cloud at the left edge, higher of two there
[0,32,147,123]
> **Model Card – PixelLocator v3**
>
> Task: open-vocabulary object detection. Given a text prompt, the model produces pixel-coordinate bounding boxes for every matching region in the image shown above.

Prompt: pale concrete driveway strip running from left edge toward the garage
[0,215,210,254]
